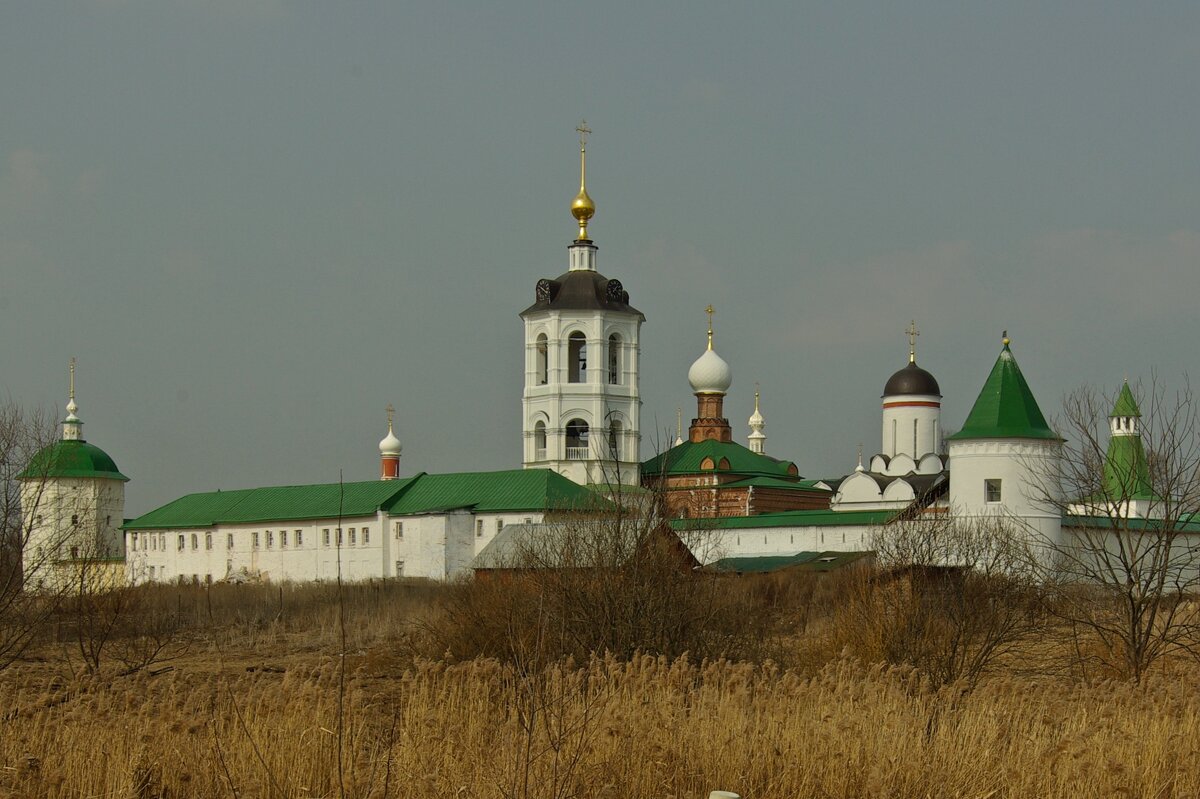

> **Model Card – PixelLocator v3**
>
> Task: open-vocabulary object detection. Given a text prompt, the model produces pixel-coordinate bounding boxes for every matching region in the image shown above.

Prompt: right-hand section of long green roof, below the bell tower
[388,469,611,516]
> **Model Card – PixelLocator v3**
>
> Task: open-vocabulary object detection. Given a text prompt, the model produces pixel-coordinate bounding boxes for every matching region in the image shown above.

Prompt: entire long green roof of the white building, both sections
[125,469,604,530]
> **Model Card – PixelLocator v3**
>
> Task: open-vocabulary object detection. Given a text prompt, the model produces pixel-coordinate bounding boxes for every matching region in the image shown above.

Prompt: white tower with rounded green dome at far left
[18,359,128,588]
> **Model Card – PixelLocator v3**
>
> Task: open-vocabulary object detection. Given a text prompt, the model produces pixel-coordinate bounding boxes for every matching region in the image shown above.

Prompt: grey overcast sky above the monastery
[0,0,1200,515]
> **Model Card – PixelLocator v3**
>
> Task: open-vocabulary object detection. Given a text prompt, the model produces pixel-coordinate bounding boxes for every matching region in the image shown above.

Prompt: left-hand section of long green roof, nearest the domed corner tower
[125,475,422,530]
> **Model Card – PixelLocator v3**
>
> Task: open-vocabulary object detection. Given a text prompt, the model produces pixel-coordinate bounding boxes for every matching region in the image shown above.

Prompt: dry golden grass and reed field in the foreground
[0,585,1200,799]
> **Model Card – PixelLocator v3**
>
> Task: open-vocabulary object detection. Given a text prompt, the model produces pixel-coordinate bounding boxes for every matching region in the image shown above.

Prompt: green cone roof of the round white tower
[947,341,1062,441]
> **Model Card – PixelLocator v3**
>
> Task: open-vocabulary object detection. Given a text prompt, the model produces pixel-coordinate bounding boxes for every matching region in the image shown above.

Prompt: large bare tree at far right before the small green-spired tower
[1040,378,1200,681]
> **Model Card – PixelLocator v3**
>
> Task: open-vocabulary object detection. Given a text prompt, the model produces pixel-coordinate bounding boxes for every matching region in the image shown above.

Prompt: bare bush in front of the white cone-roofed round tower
[841,510,1043,685]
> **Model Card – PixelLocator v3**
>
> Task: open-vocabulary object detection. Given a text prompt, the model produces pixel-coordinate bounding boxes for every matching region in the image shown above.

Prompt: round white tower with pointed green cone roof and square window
[946,331,1062,543]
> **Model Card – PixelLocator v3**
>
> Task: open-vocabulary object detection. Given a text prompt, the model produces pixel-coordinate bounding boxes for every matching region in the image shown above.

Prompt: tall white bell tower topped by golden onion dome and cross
[521,124,646,485]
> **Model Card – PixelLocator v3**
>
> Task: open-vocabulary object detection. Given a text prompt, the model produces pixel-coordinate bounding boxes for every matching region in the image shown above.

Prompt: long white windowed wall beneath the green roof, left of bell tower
[125,510,544,583]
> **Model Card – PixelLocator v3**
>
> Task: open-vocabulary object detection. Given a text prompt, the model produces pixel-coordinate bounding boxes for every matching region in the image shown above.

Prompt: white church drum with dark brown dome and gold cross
[880,322,942,463]
